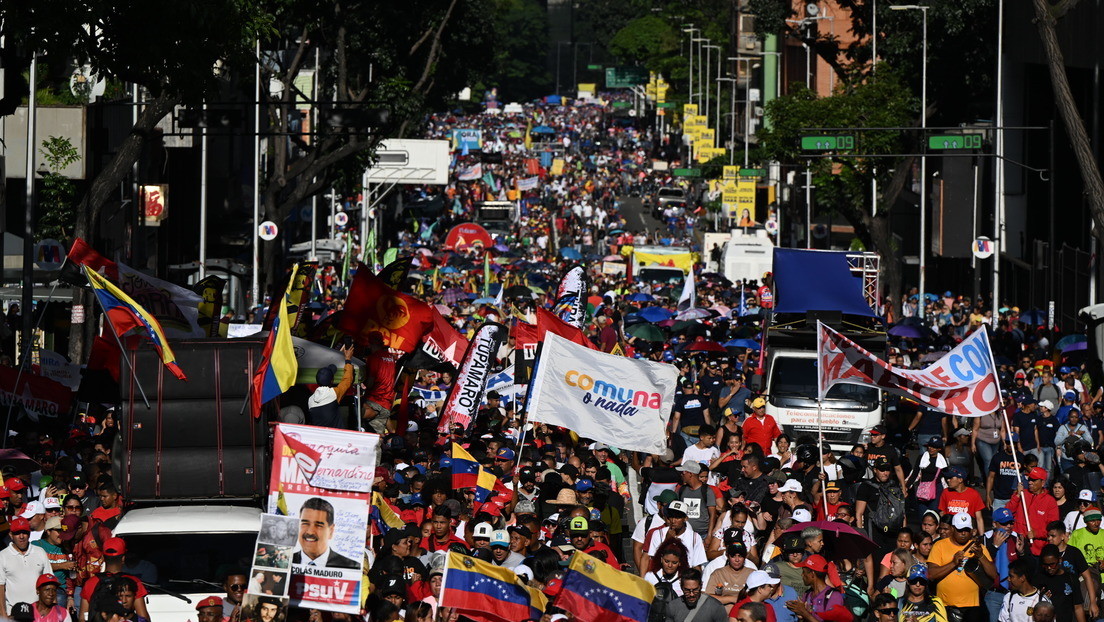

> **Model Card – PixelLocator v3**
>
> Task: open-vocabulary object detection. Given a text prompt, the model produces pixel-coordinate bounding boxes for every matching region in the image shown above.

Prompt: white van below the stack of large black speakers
[115,505,261,622]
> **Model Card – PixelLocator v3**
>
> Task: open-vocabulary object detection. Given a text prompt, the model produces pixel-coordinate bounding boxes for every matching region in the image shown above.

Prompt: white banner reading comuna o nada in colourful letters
[529,331,679,453]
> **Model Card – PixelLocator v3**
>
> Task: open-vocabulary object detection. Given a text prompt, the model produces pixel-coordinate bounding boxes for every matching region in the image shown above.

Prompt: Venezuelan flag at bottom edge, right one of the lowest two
[553,552,656,622]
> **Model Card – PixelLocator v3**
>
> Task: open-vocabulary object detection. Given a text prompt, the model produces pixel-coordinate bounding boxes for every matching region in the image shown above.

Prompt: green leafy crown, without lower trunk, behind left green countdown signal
[758,65,915,215]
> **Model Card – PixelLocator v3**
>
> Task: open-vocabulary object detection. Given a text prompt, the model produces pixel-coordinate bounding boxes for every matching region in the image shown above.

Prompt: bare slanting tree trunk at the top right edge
[1032,0,1104,236]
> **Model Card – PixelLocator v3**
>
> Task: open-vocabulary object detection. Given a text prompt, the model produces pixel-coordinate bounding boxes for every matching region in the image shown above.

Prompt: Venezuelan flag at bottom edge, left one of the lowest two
[440,551,543,622]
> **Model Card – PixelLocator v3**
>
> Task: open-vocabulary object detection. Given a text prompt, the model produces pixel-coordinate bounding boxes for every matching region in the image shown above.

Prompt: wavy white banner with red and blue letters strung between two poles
[817,323,1000,417]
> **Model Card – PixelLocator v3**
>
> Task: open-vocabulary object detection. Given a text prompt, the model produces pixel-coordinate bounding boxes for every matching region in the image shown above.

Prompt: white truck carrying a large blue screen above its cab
[753,249,885,451]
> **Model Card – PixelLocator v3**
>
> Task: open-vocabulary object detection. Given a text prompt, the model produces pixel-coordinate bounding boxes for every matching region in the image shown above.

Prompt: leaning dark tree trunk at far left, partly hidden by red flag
[68,93,178,363]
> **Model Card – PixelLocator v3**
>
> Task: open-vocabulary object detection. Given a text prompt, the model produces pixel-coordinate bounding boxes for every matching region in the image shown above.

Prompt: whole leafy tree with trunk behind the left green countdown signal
[760,71,913,311]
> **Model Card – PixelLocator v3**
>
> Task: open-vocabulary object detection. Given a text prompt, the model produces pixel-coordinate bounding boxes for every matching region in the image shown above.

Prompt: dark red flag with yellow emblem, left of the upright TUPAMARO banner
[338,268,433,352]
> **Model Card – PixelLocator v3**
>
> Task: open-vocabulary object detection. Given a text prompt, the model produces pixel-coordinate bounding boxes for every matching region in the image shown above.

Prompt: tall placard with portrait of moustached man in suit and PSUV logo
[264,423,380,613]
